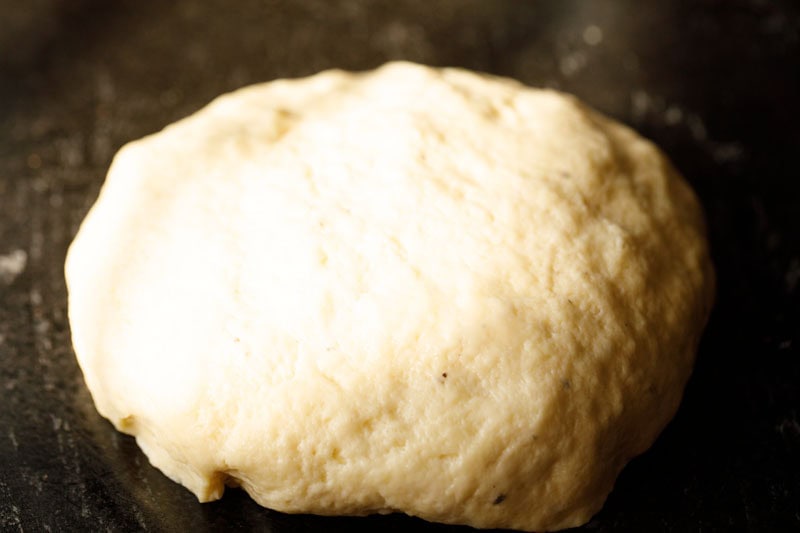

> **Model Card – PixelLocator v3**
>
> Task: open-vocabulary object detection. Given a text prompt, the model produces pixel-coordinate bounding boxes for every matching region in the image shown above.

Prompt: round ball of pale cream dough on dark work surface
[66,63,713,530]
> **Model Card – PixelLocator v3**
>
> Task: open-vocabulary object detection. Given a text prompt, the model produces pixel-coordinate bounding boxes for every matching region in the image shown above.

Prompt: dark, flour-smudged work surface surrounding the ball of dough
[0,0,800,532]
